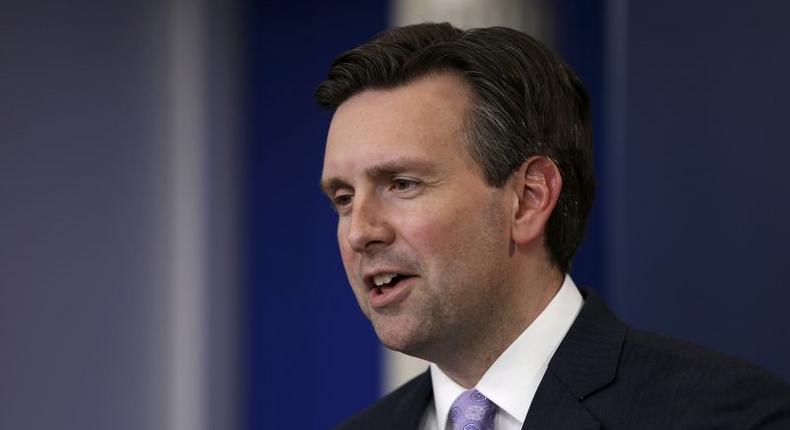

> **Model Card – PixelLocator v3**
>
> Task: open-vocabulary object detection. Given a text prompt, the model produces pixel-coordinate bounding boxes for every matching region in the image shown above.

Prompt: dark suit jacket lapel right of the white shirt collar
[523,288,626,430]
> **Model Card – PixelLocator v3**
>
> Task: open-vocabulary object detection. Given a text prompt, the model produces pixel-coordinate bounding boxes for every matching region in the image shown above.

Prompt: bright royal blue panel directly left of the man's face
[245,0,387,429]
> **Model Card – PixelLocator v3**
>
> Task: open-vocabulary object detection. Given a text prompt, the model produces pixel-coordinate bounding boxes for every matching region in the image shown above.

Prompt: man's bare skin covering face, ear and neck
[322,73,563,388]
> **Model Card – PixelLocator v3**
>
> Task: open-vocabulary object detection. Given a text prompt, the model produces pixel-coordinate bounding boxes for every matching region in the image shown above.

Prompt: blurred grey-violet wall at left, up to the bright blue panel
[0,0,237,429]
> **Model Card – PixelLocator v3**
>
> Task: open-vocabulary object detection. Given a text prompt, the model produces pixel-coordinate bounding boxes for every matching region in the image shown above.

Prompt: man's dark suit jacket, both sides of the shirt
[338,289,790,430]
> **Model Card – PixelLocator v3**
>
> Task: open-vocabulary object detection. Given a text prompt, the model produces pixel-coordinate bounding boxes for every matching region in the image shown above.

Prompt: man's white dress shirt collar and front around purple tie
[420,275,584,430]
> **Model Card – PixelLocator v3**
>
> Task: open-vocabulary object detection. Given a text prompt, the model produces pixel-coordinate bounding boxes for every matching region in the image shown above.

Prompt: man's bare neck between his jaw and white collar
[431,265,564,389]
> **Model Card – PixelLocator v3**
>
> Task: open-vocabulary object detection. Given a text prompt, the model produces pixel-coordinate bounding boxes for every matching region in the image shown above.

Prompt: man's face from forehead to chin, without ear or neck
[322,74,512,359]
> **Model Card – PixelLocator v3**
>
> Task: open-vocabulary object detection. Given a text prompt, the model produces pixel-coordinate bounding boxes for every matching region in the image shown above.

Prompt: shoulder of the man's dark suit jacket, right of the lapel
[590,329,790,429]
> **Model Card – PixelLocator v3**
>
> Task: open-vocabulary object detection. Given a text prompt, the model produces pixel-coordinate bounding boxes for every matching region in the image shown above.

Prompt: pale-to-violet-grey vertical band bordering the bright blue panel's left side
[166,0,243,430]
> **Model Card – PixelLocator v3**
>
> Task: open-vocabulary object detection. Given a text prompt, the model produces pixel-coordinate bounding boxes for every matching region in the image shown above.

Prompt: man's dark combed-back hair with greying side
[315,23,594,272]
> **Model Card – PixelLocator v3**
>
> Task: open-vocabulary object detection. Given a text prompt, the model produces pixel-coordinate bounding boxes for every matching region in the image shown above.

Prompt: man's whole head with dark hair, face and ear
[317,24,592,362]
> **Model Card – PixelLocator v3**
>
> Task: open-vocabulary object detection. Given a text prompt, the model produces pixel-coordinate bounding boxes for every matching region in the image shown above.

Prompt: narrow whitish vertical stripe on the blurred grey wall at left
[168,0,207,430]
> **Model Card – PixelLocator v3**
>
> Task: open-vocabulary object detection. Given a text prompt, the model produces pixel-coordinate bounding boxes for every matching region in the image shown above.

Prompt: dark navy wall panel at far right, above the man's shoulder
[608,0,790,380]
